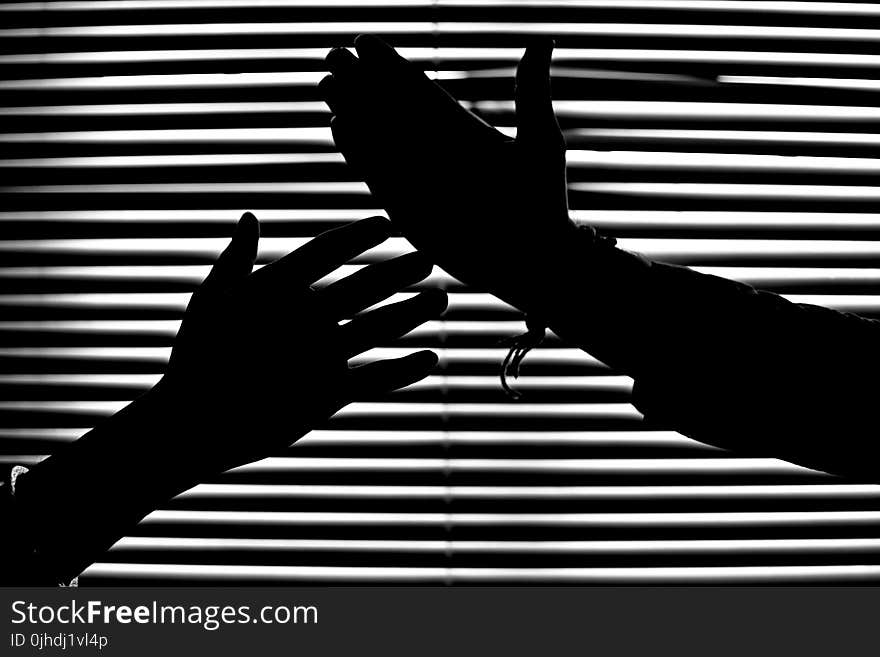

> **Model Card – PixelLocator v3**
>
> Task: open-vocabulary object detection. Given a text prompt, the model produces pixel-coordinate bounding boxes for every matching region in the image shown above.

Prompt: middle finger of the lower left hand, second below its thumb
[319,253,432,320]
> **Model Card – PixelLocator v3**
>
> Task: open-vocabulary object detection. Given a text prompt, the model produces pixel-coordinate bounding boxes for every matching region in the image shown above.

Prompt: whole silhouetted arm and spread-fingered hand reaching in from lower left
[0,213,446,585]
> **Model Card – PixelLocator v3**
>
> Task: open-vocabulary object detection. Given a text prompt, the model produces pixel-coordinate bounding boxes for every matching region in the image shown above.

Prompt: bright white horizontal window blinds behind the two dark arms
[0,0,880,584]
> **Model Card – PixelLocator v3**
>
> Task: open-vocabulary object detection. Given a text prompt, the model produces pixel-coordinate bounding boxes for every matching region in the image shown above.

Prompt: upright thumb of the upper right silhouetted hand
[515,38,562,147]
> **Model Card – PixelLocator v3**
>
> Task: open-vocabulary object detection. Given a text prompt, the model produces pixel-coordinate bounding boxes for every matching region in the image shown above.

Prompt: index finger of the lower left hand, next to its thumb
[252,217,391,285]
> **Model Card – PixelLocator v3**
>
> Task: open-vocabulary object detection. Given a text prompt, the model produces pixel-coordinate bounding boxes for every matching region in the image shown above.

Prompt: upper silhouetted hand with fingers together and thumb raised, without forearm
[320,36,573,303]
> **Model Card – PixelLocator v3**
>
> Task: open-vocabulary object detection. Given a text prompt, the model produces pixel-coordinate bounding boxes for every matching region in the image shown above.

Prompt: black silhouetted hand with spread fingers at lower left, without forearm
[156,213,446,481]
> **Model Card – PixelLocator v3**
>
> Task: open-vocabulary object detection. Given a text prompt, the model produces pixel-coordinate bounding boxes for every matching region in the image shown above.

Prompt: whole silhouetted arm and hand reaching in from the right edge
[320,36,880,481]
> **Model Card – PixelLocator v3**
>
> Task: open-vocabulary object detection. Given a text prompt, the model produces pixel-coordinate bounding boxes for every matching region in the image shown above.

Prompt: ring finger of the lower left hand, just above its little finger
[339,290,447,358]
